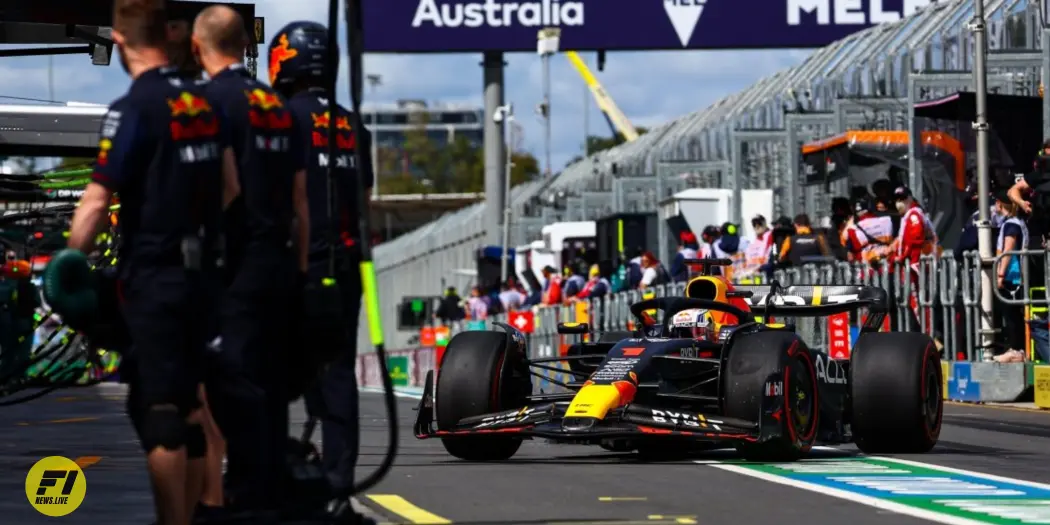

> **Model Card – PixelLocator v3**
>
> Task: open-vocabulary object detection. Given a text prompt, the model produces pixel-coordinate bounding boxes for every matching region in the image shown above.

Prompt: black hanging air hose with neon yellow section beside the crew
[329,0,399,495]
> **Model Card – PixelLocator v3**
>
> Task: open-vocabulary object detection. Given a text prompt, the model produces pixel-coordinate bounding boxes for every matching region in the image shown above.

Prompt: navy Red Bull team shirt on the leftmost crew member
[91,67,229,277]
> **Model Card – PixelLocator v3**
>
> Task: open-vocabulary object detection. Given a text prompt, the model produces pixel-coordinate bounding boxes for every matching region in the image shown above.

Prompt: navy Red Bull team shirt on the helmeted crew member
[289,89,375,266]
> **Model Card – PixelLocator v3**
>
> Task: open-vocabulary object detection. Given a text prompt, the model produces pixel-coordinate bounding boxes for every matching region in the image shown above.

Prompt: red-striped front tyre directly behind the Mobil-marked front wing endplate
[721,331,820,462]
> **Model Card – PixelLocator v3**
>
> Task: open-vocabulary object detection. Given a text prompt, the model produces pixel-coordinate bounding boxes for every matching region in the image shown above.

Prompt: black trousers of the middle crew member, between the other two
[206,265,296,508]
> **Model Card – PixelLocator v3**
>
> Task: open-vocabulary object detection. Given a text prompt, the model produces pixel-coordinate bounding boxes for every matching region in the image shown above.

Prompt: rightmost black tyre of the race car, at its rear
[849,332,944,454]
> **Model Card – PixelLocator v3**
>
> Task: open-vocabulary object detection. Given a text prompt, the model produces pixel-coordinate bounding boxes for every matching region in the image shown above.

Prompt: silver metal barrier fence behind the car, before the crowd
[443,251,1050,373]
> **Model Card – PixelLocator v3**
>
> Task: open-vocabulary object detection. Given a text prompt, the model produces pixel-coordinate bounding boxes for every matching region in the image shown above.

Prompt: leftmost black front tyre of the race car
[435,331,532,461]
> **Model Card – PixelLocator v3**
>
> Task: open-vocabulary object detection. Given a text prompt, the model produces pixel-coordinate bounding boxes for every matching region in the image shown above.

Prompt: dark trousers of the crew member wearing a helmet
[305,257,361,489]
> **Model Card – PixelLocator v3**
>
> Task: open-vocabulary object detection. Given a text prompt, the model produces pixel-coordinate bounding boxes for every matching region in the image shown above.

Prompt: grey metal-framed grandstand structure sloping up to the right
[362,0,1050,349]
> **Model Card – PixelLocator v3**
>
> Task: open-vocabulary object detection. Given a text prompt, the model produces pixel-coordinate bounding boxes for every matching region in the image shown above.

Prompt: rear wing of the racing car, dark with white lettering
[734,285,889,317]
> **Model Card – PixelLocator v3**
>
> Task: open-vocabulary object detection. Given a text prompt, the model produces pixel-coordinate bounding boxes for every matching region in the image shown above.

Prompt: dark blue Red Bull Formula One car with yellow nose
[415,260,944,461]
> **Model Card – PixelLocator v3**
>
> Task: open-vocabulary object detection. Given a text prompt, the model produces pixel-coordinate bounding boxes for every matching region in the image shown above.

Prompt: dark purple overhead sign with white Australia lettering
[363,0,935,53]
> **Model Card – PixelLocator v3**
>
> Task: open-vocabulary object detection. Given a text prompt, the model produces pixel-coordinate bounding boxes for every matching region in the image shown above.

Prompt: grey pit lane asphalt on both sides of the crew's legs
[0,387,1050,525]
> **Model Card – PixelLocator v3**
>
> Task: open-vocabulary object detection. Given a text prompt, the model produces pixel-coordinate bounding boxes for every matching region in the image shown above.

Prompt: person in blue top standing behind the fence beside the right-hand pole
[994,192,1028,362]
